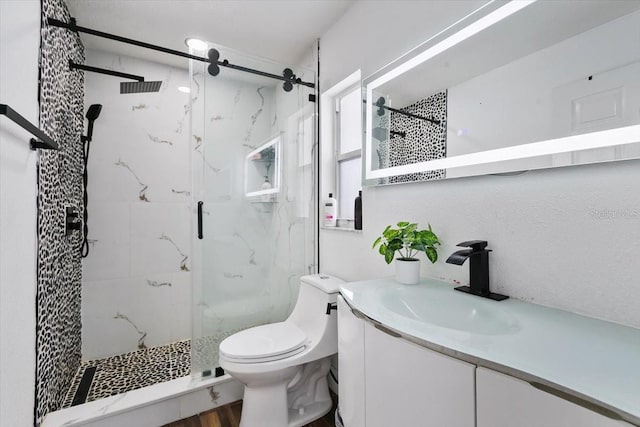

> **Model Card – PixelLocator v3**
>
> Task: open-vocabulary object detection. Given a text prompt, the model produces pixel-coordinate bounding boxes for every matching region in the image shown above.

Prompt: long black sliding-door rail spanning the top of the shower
[47,18,315,88]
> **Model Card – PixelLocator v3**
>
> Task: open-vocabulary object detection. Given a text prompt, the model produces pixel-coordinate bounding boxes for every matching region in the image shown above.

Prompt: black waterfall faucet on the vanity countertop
[446,240,509,301]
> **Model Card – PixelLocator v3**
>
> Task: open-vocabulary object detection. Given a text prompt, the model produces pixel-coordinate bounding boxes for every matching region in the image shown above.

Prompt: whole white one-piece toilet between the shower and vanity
[220,274,344,427]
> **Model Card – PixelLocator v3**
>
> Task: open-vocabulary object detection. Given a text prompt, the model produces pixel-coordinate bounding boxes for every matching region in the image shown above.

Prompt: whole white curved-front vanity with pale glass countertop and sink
[338,278,640,427]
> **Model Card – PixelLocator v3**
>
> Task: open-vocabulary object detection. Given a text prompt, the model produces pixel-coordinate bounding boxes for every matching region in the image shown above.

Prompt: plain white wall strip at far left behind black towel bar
[0,0,40,427]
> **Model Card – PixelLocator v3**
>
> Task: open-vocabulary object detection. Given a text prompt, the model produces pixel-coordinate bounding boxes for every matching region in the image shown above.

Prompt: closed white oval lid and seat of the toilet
[220,322,307,361]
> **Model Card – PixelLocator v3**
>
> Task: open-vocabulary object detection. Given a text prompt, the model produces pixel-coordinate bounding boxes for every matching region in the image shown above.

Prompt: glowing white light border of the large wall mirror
[364,0,640,181]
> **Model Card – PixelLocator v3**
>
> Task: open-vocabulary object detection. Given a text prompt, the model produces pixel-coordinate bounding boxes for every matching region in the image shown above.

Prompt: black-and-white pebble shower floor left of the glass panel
[62,340,191,408]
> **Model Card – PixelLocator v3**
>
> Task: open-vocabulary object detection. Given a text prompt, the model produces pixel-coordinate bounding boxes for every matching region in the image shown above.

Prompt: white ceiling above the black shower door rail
[67,0,355,67]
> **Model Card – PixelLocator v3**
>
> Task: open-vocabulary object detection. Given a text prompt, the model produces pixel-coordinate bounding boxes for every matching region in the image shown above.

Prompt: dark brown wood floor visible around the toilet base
[164,396,336,427]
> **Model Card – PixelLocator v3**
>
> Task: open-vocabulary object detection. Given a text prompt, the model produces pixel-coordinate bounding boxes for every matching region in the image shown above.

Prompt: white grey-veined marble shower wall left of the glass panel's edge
[82,51,192,360]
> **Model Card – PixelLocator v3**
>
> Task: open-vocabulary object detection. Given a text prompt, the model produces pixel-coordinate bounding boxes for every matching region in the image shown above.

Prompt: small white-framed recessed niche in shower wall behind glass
[244,135,282,203]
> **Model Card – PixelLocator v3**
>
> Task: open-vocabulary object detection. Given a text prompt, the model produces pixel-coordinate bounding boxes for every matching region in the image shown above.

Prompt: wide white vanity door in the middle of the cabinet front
[362,322,475,427]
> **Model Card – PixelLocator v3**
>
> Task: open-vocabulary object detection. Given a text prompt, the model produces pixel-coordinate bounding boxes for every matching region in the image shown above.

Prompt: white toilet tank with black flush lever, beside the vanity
[287,274,344,357]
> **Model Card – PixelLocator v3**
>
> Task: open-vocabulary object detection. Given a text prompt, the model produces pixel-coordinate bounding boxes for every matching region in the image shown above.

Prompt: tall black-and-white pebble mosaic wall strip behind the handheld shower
[35,0,84,424]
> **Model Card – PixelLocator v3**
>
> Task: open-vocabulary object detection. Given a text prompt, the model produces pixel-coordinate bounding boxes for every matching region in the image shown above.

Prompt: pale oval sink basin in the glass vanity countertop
[379,286,520,335]
